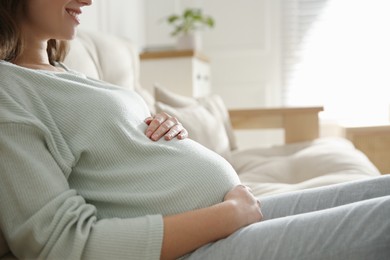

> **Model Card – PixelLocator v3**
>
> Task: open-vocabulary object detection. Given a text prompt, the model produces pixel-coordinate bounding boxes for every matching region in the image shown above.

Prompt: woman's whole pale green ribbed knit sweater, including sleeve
[0,61,239,259]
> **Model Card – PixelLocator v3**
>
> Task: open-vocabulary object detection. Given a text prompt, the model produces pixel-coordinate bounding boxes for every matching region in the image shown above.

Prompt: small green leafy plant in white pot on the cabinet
[166,8,215,50]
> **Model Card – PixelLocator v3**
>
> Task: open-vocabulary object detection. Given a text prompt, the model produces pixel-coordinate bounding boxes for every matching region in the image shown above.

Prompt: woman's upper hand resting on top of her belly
[145,112,188,141]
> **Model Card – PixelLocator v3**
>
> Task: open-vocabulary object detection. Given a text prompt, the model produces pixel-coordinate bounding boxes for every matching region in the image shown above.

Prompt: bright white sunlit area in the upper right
[288,0,390,123]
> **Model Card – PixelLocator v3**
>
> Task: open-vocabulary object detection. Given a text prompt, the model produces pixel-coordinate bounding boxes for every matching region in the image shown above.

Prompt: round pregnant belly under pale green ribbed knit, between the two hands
[71,140,240,217]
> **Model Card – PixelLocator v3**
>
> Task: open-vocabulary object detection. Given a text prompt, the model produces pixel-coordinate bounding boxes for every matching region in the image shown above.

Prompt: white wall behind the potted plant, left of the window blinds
[145,0,281,108]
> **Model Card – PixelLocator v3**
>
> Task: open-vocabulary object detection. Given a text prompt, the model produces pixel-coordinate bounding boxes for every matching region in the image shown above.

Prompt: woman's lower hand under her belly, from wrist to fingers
[224,185,263,228]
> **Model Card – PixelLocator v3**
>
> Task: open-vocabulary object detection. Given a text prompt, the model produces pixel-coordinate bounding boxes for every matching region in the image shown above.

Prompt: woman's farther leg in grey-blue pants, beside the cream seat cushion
[260,175,390,220]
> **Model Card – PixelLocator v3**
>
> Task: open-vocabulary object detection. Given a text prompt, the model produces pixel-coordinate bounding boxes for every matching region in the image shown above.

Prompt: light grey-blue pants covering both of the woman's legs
[189,175,390,260]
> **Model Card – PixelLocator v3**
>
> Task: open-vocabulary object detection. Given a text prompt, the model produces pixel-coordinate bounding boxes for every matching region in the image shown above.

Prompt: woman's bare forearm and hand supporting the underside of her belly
[161,185,263,259]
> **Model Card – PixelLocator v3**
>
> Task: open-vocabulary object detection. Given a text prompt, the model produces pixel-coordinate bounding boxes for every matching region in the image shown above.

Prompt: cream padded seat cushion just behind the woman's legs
[231,138,380,196]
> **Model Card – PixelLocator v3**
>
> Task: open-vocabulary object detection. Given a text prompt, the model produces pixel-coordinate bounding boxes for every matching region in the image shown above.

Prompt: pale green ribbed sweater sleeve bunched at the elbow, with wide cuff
[0,123,163,259]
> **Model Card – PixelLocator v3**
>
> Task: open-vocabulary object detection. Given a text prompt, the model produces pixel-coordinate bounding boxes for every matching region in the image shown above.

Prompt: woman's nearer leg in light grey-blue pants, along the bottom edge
[189,196,390,260]
